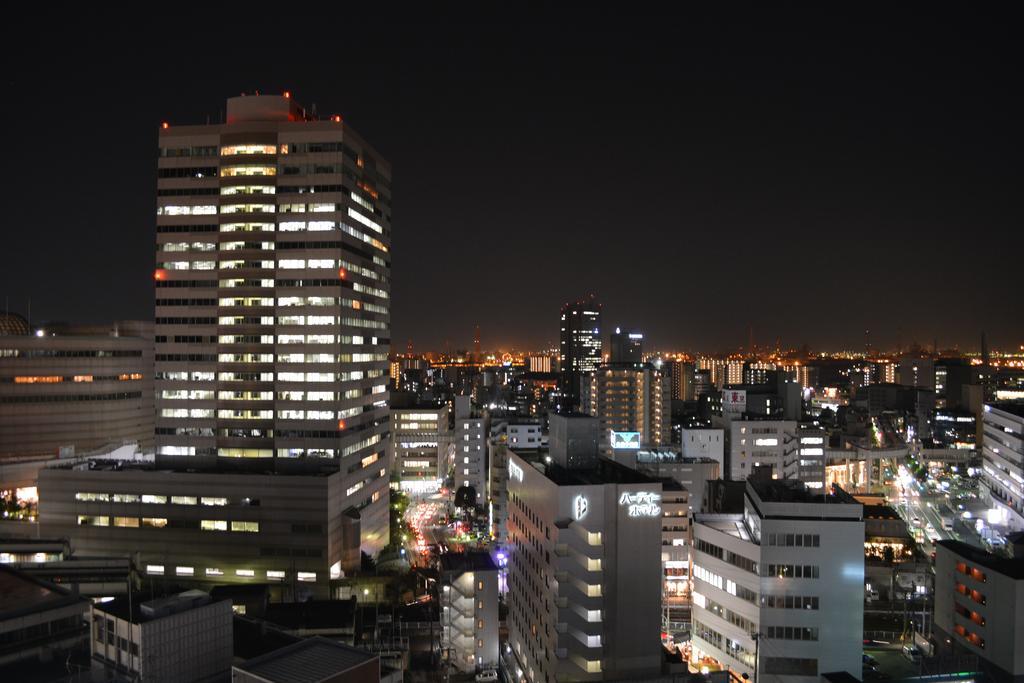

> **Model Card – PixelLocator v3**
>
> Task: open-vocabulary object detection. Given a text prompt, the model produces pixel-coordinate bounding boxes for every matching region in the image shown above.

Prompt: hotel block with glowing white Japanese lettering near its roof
[508,453,663,683]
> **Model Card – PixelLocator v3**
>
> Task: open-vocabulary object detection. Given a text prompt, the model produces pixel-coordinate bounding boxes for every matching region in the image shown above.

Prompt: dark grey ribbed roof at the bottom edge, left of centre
[234,636,377,683]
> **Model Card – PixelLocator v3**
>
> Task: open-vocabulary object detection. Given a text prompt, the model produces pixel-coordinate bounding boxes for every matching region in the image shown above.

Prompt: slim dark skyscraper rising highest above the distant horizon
[558,294,601,410]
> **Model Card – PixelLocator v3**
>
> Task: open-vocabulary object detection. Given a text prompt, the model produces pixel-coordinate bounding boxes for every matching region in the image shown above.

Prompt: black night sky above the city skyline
[0,3,1024,350]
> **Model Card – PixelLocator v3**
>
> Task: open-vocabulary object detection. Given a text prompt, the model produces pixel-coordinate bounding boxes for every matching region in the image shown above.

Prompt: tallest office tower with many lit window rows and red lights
[155,93,391,538]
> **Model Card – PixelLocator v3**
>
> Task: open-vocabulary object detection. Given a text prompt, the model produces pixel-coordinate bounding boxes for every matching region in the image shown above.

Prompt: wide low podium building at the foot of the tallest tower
[39,463,376,599]
